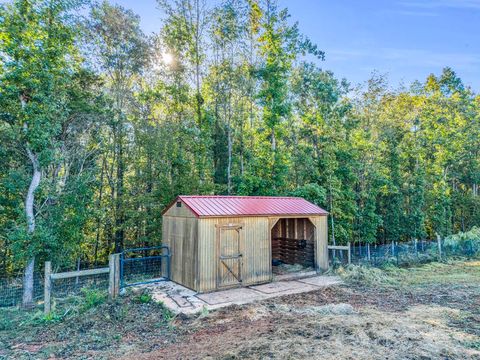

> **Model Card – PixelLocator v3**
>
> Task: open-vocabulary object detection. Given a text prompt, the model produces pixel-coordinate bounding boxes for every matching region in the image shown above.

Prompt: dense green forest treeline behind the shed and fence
[0,0,480,301]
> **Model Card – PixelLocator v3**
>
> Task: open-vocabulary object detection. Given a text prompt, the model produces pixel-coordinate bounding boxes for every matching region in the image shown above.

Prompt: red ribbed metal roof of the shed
[171,196,328,217]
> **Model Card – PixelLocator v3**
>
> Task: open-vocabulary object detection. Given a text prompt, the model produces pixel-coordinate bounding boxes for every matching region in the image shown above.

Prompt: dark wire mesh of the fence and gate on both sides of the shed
[0,240,480,307]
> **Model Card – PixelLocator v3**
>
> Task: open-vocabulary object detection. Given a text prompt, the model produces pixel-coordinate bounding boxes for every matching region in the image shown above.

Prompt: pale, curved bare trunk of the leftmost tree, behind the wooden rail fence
[22,147,42,308]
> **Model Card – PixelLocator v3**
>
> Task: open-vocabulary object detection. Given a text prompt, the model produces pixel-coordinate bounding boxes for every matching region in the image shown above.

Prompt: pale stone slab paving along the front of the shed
[136,275,341,315]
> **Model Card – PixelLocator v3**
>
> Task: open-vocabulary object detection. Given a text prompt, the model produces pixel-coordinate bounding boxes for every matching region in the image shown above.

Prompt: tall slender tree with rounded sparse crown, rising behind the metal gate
[88,1,148,252]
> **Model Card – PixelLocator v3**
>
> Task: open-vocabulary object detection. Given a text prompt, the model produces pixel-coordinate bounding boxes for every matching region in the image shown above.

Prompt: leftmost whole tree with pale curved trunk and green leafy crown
[0,0,94,307]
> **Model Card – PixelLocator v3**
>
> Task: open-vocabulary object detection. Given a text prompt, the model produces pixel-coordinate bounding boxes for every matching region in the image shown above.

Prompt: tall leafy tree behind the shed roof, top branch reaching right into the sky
[253,0,324,191]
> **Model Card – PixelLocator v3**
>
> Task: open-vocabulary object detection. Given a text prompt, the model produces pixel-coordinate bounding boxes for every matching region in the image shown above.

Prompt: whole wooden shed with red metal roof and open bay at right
[163,196,328,292]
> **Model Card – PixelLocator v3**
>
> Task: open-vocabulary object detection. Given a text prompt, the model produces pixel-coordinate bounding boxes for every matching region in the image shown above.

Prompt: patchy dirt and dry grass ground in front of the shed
[0,261,480,360]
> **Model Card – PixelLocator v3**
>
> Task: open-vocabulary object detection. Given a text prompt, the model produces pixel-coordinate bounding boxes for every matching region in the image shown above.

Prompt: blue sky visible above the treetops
[115,0,480,92]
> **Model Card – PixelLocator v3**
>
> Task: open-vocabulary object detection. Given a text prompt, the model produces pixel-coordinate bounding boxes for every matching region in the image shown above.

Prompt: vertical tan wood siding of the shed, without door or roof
[163,210,328,292]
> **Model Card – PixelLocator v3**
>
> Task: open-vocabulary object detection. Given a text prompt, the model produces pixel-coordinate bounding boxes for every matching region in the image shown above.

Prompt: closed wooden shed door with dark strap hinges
[217,224,243,287]
